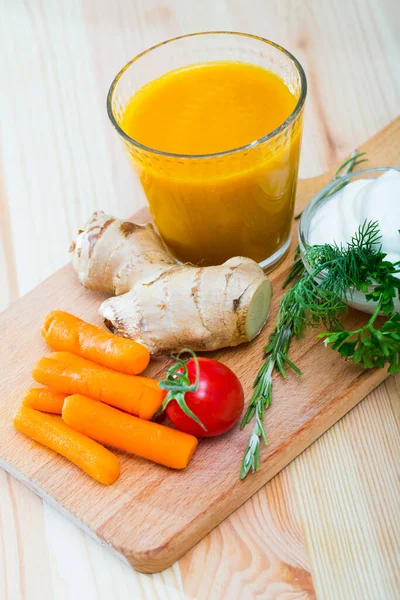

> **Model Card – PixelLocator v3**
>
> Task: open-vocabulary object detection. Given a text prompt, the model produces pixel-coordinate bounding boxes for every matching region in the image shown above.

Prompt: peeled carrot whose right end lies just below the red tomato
[62,394,198,469]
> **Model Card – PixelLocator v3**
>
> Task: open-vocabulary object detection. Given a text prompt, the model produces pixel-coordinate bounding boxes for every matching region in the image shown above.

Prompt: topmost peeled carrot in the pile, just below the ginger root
[42,310,150,375]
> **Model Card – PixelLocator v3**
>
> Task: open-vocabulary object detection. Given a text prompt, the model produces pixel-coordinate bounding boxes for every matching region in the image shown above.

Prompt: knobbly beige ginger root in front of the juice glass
[72,212,272,354]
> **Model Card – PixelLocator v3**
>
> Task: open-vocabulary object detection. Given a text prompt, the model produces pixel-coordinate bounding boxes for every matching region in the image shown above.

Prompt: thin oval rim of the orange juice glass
[107,31,307,159]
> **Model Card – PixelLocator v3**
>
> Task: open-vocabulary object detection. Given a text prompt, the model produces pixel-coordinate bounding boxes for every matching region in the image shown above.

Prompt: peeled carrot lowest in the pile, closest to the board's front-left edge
[14,406,119,485]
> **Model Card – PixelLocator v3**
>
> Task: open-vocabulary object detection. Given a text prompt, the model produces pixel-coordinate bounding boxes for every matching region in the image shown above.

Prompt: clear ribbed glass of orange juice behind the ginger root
[107,32,307,270]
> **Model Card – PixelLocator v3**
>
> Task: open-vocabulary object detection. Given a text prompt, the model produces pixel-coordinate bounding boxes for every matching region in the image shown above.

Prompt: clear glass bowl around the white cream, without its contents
[299,167,400,314]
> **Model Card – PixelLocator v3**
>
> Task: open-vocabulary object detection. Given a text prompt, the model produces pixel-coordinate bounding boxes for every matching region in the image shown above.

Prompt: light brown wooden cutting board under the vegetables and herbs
[0,118,400,573]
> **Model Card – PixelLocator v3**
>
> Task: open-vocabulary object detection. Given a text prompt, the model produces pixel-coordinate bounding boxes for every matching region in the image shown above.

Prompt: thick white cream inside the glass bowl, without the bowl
[307,169,400,312]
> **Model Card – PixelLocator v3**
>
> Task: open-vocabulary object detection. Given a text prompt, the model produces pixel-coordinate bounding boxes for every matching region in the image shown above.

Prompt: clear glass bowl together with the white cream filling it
[299,167,400,313]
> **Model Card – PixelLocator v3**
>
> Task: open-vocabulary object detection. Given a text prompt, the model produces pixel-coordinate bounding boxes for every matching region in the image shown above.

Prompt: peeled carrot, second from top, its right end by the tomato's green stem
[32,352,165,420]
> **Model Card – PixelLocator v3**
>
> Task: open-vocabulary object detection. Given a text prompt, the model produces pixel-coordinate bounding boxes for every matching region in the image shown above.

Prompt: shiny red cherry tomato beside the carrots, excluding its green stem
[166,358,244,437]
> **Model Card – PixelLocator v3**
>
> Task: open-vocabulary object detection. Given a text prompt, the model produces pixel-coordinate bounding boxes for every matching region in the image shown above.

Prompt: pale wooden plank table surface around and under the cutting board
[0,0,400,600]
